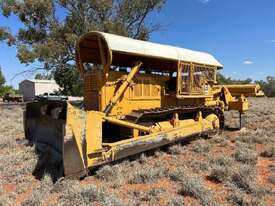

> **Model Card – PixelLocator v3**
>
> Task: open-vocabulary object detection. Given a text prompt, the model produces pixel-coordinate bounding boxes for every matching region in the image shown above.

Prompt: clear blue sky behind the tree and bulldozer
[0,0,275,86]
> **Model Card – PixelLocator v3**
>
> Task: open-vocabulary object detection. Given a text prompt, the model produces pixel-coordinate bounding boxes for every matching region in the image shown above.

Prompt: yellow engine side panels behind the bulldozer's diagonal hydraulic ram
[99,72,169,116]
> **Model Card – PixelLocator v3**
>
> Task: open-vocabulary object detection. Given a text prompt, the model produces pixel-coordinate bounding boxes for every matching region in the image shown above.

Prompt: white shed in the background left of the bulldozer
[19,79,60,101]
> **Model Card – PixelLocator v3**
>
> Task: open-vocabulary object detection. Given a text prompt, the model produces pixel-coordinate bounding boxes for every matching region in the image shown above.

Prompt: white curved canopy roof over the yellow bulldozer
[76,31,223,72]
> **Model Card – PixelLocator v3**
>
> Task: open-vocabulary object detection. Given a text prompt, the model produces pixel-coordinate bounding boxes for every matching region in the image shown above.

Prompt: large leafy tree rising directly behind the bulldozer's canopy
[0,0,165,94]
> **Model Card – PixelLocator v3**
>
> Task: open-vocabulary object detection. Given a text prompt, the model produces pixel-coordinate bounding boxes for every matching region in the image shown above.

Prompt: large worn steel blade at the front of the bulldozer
[24,100,86,177]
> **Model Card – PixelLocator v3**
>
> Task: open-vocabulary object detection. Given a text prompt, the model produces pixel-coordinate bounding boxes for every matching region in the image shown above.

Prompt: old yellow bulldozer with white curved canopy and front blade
[24,31,264,177]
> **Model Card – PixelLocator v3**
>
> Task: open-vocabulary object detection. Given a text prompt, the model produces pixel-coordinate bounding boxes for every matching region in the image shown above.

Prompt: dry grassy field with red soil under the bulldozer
[0,98,275,206]
